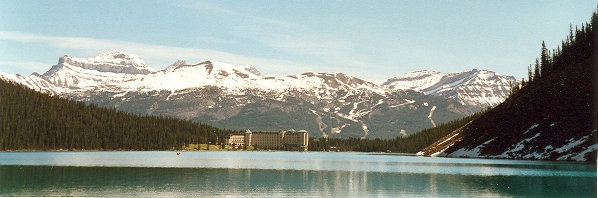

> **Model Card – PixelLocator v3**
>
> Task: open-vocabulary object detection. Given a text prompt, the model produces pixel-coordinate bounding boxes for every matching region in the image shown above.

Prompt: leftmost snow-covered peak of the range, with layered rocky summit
[0,52,155,95]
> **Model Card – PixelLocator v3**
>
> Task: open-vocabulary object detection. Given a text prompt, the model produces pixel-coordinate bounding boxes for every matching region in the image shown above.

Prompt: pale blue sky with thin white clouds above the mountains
[0,0,598,83]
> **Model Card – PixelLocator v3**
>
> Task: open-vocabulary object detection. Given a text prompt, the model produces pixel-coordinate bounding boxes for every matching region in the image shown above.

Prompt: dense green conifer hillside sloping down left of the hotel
[0,79,230,150]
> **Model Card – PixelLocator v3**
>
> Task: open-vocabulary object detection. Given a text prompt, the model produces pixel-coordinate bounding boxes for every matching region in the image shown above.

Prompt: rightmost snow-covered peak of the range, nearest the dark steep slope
[382,69,515,108]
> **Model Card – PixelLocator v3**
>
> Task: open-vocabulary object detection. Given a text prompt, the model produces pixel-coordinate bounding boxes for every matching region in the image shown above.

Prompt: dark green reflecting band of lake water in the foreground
[0,166,596,197]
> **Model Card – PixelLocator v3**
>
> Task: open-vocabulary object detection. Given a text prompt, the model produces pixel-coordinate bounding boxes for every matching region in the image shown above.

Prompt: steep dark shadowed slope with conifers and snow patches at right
[422,8,598,161]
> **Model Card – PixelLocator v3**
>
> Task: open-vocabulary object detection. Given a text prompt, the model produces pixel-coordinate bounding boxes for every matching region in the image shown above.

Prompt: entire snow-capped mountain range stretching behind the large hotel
[0,52,508,138]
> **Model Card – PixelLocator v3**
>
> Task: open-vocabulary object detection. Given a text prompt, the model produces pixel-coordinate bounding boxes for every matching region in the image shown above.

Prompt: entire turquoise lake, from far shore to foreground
[0,151,596,197]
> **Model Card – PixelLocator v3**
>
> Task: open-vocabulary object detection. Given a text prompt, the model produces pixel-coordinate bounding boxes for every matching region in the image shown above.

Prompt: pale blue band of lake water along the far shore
[0,152,596,178]
